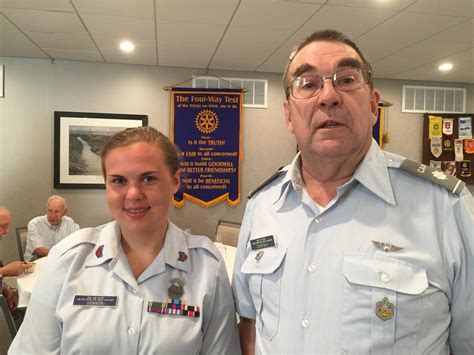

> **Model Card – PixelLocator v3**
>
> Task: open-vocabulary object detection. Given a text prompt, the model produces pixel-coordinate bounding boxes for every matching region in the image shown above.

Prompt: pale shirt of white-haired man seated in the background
[24,215,79,261]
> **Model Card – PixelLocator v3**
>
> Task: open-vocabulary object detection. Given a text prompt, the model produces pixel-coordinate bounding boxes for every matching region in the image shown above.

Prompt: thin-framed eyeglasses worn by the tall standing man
[286,68,371,99]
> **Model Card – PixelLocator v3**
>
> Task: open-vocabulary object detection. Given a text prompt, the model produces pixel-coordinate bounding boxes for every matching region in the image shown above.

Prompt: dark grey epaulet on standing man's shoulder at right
[400,159,466,196]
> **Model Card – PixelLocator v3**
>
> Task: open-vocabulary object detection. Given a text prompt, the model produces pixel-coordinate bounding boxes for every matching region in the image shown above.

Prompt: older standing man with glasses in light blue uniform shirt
[233,30,474,355]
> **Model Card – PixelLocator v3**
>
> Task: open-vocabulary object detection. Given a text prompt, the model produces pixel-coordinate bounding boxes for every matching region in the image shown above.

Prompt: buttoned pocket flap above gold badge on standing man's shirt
[343,253,428,295]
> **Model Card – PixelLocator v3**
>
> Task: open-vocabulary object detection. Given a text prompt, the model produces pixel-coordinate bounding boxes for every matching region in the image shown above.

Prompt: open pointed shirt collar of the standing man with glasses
[273,140,396,210]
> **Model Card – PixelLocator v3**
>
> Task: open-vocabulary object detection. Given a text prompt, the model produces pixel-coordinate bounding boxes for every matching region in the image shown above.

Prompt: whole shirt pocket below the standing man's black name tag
[241,248,286,340]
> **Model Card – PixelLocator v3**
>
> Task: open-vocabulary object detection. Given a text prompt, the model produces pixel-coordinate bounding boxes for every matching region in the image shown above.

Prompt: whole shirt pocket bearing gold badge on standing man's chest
[341,253,428,354]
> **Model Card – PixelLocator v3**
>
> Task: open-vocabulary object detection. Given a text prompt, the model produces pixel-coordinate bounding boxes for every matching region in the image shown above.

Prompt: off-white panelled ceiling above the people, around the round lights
[0,0,474,83]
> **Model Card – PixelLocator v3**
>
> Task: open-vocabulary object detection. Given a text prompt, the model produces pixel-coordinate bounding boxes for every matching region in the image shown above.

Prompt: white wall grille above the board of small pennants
[402,85,466,113]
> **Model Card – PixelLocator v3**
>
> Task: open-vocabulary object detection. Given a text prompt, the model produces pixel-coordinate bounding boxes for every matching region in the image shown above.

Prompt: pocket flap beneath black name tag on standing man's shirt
[241,248,286,274]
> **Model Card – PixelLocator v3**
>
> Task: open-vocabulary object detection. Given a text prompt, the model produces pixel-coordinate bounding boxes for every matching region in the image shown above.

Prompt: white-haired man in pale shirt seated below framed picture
[25,195,79,261]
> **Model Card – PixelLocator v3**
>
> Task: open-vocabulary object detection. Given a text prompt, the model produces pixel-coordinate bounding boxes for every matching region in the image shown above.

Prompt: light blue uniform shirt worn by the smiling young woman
[9,222,240,355]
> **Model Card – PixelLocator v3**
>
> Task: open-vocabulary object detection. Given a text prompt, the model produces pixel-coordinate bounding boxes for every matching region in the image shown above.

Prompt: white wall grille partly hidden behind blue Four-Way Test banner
[193,76,268,108]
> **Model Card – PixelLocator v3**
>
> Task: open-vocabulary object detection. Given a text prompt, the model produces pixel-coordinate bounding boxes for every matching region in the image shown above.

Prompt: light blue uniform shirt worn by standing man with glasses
[233,142,474,355]
